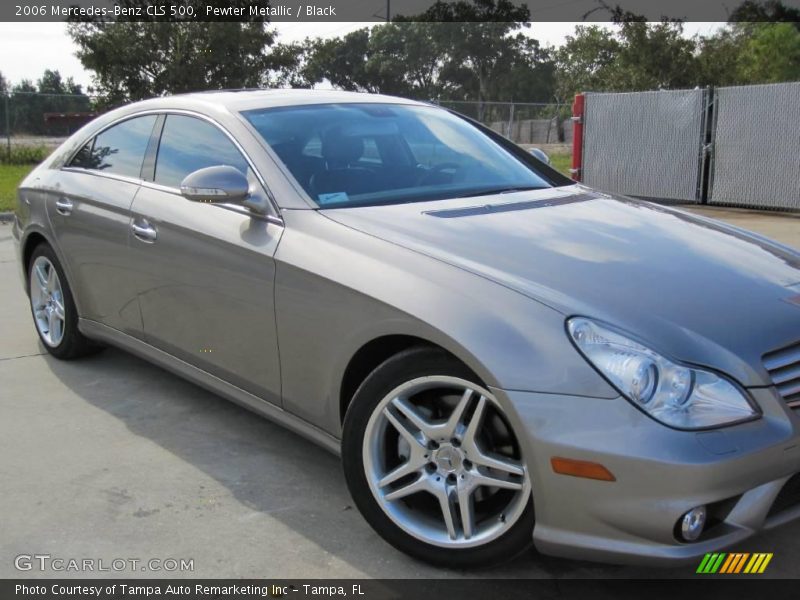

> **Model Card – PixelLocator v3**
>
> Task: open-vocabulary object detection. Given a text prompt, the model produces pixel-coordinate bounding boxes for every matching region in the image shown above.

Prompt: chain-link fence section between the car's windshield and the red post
[437,100,572,145]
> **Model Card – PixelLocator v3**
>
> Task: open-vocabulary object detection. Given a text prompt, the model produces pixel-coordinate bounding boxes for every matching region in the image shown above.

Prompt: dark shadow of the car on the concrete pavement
[40,348,797,578]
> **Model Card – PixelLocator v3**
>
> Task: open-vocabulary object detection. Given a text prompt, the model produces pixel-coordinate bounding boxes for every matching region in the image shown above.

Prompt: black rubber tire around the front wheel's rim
[342,346,534,569]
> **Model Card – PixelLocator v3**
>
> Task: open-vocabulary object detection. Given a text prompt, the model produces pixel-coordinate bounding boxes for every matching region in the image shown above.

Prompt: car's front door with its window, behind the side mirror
[130,114,283,403]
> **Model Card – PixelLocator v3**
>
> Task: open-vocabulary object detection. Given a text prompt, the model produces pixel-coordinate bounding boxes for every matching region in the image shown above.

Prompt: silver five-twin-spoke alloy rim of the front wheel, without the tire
[363,376,531,548]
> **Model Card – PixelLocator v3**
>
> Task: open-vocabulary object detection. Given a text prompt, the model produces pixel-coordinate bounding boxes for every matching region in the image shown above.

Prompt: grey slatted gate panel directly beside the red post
[582,89,708,202]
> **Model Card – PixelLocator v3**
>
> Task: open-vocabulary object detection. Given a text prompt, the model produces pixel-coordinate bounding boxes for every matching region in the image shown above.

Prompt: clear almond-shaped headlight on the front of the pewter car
[567,317,758,429]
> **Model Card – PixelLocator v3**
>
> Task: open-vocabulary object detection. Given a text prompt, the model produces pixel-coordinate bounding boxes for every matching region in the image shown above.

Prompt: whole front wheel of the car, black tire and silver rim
[342,347,534,568]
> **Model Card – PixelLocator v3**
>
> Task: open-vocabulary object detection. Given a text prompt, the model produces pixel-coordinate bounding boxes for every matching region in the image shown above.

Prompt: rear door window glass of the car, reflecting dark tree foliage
[69,115,156,178]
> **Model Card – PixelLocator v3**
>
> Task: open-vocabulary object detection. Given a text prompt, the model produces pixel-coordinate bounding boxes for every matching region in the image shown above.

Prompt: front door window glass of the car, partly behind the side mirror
[155,115,247,188]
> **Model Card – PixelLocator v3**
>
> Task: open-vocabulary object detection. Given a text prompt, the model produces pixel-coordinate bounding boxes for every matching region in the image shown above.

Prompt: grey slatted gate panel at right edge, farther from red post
[708,83,800,209]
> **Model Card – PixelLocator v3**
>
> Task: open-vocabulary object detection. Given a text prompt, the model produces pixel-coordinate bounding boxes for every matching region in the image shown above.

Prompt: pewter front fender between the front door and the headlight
[275,211,618,435]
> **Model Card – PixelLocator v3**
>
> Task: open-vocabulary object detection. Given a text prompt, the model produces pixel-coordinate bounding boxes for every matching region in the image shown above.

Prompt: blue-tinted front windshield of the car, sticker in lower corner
[243,103,550,208]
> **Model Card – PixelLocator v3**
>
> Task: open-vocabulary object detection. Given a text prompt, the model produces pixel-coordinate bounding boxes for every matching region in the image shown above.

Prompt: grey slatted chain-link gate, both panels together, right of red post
[582,82,800,211]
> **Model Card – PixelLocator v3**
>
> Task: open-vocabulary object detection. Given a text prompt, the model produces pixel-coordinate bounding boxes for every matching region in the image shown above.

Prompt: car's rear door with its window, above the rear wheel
[47,114,158,336]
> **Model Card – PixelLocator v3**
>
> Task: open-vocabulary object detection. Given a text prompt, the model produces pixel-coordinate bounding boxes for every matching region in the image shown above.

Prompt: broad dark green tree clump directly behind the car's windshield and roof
[301,13,555,111]
